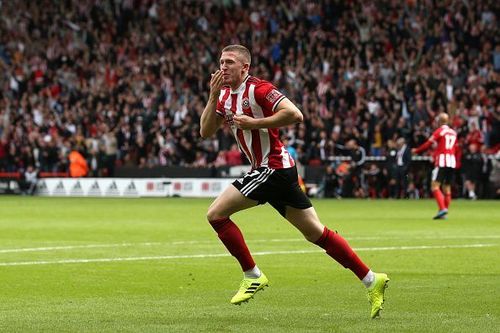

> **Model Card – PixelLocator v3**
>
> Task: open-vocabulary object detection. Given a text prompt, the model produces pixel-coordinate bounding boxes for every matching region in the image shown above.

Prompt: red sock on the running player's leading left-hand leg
[210,217,255,271]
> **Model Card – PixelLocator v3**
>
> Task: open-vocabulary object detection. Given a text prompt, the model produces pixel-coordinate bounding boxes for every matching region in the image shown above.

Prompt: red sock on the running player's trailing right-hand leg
[315,227,370,280]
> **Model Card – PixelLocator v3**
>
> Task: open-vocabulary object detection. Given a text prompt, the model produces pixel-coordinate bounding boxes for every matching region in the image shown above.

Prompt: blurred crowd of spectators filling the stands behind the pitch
[0,0,500,197]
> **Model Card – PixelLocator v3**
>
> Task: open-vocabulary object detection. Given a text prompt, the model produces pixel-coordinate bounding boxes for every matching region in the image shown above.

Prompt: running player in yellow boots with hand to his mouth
[200,45,389,318]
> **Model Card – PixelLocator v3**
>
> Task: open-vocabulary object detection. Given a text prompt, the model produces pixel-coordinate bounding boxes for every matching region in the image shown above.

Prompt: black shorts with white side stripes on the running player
[233,166,312,217]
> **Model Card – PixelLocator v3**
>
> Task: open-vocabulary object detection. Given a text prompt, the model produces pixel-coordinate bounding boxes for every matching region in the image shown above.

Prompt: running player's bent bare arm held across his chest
[233,97,304,130]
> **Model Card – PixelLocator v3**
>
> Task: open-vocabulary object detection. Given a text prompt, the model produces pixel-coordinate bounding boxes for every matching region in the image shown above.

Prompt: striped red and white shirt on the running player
[216,75,295,169]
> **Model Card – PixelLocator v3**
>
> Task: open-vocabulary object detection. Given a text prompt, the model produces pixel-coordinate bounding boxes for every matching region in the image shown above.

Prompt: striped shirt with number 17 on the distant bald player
[416,125,457,169]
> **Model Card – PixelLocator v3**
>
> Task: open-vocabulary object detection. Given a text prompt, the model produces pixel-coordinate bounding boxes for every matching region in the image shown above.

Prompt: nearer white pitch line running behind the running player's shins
[0,244,498,266]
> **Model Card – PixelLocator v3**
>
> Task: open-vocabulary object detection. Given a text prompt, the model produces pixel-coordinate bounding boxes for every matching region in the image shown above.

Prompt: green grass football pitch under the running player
[0,197,500,333]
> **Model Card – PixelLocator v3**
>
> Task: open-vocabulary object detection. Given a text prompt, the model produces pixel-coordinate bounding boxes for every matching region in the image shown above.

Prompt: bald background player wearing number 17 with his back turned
[412,113,457,220]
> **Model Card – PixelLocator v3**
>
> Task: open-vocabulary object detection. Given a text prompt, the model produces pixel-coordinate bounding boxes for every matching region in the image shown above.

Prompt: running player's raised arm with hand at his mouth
[200,70,224,138]
